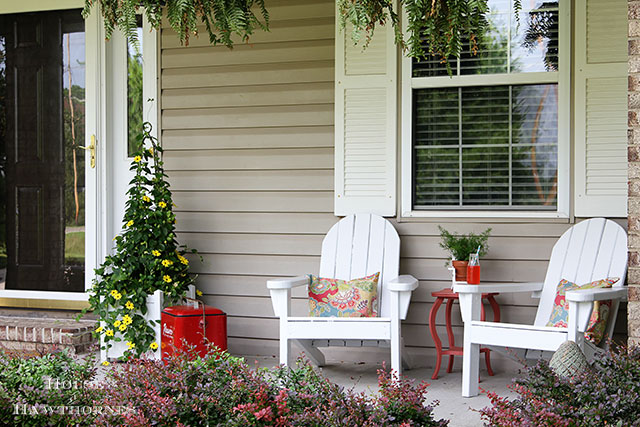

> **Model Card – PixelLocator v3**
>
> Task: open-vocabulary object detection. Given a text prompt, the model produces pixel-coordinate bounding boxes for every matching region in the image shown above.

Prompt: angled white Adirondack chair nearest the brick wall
[453,218,627,397]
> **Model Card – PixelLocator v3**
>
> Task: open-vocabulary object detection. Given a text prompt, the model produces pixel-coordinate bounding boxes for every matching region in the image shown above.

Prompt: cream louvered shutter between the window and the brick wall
[575,0,627,217]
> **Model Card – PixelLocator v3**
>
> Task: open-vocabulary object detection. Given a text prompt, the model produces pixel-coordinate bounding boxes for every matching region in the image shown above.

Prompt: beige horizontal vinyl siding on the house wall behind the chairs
[161,0,624,366]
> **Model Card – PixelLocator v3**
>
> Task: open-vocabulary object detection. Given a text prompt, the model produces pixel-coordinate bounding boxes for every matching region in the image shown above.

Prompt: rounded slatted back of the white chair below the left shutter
[320,214,400,317]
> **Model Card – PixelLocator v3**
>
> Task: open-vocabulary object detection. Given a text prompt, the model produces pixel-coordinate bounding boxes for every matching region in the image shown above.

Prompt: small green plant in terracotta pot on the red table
[438,226,491,281]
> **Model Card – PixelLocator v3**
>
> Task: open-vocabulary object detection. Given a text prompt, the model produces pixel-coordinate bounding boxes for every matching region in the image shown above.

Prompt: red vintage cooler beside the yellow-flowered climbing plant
[161,305,227,359]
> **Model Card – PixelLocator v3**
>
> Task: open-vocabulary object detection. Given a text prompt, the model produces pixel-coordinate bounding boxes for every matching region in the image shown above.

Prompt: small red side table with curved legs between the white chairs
[429,288,500,380]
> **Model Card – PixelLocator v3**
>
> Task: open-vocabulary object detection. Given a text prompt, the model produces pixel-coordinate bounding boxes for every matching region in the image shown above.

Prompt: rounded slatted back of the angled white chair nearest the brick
[535,218,627,326]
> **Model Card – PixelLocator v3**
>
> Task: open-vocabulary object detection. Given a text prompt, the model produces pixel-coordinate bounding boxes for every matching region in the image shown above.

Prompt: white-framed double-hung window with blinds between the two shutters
[403,0,569,216]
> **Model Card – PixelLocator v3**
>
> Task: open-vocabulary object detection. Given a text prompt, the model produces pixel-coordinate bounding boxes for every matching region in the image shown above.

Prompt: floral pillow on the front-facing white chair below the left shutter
[309,273,380,317]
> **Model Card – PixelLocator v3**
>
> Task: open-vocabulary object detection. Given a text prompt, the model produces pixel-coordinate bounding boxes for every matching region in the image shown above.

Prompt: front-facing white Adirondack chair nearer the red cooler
[267,214,418,372]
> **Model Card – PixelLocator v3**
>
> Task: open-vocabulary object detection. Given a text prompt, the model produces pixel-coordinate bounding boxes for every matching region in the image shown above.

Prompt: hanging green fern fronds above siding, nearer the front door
[83,0,269,47]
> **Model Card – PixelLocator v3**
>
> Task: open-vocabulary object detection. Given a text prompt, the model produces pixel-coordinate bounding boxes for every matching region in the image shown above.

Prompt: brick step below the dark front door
[0,316,96,354]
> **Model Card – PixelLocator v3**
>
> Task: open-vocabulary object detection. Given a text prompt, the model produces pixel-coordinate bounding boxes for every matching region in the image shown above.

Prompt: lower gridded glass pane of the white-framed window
[413,84,558,210]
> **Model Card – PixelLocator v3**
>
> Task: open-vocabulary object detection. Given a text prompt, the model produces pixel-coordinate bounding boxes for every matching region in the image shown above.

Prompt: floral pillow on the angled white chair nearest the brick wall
[547,277,620,345]
